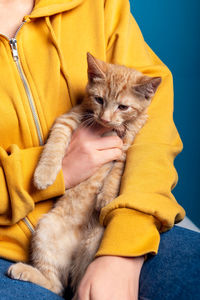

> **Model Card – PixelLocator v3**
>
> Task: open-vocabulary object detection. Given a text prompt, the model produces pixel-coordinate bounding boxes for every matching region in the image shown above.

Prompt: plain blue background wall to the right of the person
[130,0,200,226]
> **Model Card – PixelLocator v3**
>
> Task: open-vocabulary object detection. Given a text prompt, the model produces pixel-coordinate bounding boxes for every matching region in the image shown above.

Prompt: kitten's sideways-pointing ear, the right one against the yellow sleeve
[133,76,162,100]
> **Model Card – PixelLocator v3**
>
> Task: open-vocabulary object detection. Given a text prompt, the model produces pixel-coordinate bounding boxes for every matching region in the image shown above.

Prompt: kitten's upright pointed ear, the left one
[87,52,106,82]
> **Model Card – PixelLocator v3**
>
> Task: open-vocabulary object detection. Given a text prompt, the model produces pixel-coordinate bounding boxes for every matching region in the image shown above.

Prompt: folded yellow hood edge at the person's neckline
[28,0,84,19]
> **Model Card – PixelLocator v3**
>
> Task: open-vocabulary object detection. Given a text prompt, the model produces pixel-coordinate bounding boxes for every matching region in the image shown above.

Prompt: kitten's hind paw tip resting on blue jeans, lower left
[7,263,31,281]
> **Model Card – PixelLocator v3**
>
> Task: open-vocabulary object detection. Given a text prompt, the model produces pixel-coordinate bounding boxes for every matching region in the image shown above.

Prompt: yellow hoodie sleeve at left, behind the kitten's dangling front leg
[0,145,65,225]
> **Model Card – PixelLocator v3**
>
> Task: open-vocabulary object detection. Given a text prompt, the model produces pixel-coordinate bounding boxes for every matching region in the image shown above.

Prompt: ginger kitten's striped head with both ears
[83,53,161,129]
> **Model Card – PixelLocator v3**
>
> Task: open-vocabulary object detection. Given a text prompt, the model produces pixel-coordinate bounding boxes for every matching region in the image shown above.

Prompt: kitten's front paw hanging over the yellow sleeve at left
[33,166,58,190]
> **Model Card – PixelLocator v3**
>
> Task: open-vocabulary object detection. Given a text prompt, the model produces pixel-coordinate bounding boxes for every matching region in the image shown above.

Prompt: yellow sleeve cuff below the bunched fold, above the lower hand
[96,208,160,257]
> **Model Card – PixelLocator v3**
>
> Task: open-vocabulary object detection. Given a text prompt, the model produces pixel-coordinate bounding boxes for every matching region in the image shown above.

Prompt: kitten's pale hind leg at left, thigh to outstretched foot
[8,209,78,295]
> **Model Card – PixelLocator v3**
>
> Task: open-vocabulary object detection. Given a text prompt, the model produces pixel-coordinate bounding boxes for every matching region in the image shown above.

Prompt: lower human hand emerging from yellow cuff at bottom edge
[76,256,144,300]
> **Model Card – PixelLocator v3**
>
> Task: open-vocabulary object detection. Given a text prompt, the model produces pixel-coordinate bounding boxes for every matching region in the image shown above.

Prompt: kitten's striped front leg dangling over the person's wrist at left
[34,107,80,190]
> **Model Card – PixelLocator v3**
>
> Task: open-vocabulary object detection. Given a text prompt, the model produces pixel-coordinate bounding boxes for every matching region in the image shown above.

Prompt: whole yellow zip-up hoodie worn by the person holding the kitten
[0,0,184,261]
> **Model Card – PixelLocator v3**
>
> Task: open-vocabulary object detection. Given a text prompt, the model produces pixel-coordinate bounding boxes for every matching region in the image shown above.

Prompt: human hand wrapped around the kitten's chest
[62,127,123,189]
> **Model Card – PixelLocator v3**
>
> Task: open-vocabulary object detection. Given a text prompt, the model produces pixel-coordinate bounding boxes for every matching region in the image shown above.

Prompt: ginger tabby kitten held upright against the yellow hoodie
[8,53,161,299]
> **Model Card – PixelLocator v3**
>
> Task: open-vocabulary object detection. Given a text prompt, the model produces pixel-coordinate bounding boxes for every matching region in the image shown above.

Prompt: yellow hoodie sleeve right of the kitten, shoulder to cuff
[96,0,185,256]
